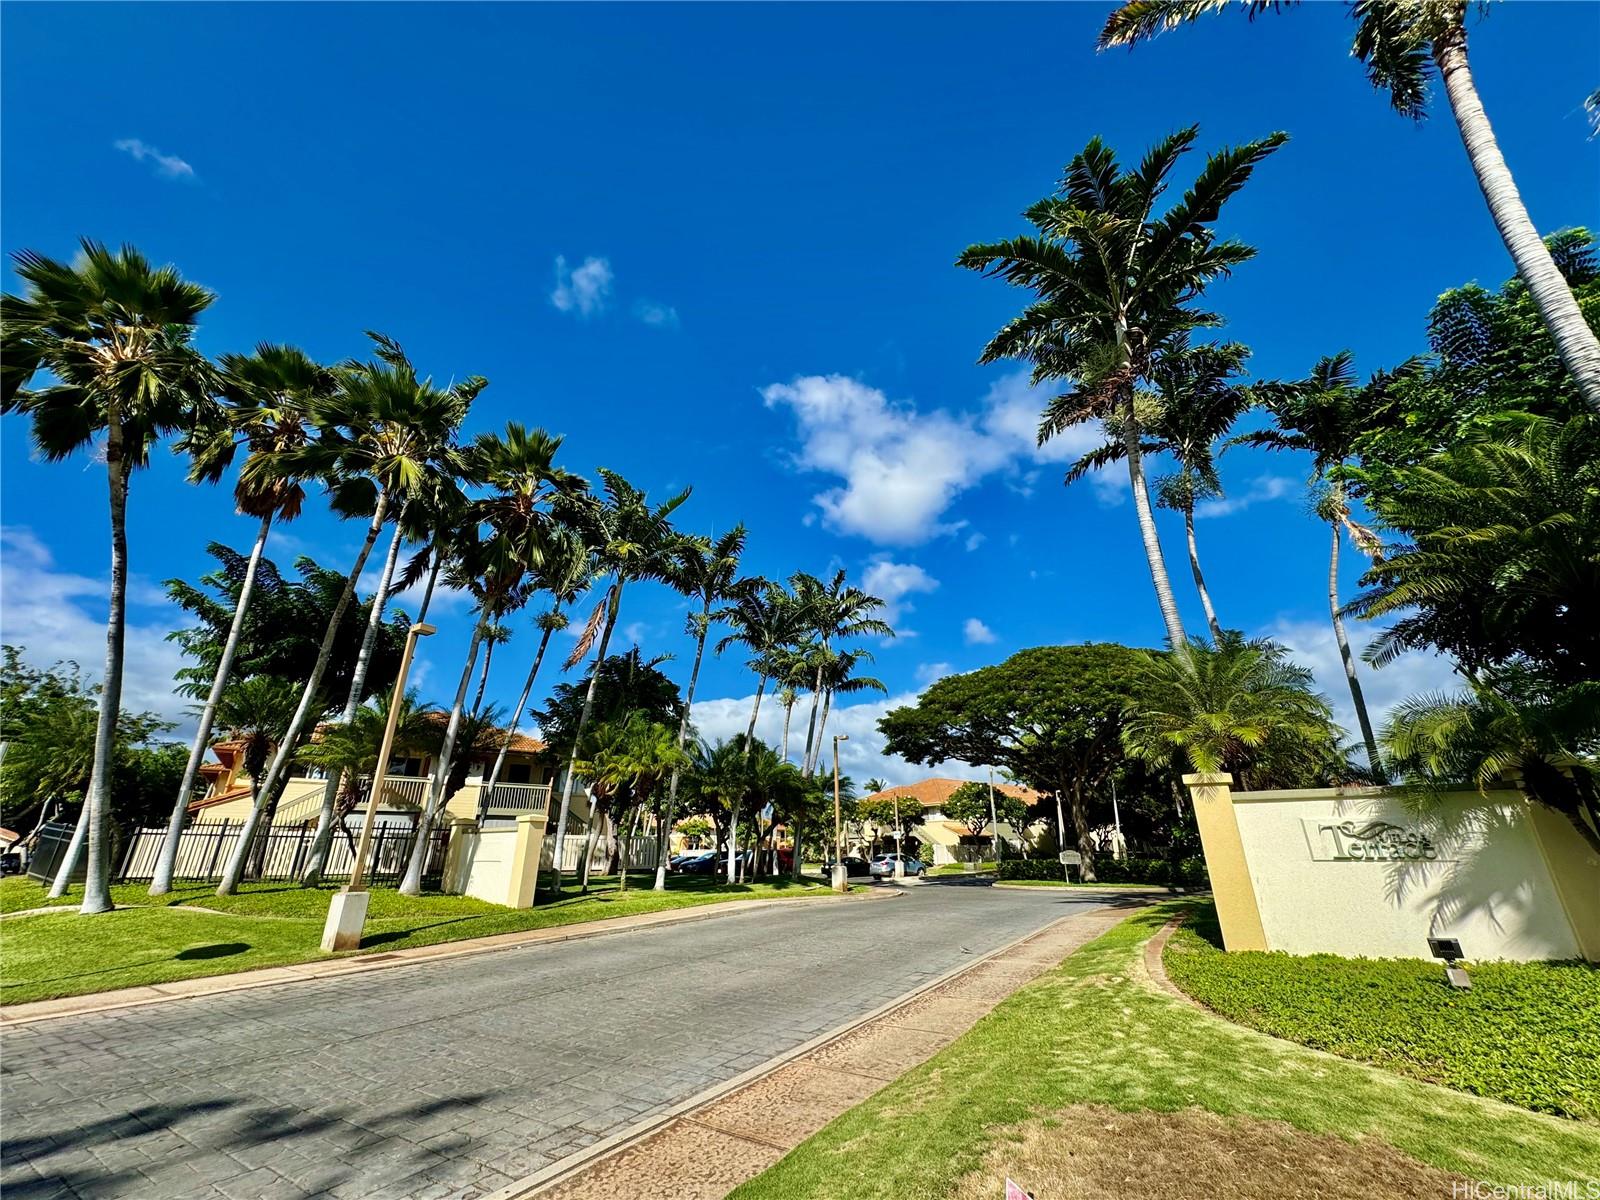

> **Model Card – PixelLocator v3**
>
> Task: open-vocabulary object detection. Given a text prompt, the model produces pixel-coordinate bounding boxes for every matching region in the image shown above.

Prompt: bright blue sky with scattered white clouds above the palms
[0,3,1600,781]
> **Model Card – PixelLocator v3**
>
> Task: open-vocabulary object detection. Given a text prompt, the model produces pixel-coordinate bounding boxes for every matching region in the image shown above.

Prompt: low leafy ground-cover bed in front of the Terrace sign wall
[1165,906,1600,1120]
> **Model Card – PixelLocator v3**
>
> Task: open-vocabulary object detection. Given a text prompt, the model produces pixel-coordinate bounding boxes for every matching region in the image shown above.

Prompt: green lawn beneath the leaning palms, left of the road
[0,872,832,1005]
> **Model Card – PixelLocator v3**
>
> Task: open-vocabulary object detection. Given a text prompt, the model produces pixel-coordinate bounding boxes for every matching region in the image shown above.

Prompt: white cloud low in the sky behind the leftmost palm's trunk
[0,525,194,738]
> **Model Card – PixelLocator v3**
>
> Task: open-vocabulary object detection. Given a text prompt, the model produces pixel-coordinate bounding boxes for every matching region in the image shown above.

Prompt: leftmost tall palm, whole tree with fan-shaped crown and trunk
[0,240,214,914]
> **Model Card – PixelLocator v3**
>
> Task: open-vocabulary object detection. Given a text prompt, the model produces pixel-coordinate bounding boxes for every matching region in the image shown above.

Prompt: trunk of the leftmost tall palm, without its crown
[69,438,130,914]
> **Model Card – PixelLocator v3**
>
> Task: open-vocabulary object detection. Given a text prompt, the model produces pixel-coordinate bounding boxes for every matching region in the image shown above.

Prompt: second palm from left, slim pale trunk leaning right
[150,342,333,896]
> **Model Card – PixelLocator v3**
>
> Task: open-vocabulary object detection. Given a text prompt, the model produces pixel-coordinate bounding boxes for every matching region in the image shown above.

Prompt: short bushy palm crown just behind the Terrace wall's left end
[1126,634,1339,793]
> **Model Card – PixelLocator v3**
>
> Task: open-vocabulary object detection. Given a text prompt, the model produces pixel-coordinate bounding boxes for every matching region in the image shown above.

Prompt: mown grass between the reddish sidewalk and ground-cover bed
[731,901,1600,1200]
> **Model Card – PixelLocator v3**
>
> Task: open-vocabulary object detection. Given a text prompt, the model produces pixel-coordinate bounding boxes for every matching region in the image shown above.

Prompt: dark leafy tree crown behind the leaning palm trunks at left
[166,542,410,709]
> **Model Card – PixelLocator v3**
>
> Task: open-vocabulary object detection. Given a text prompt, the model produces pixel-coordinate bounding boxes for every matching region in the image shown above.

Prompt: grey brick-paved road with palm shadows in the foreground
[0,883,1126,1200]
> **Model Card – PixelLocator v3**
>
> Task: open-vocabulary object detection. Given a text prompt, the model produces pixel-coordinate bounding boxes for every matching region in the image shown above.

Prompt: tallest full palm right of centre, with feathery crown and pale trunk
[957,126,1286,654]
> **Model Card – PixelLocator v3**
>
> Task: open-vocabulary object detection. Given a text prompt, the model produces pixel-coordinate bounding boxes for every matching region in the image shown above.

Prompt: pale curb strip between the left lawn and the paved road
[0,890,902,1030]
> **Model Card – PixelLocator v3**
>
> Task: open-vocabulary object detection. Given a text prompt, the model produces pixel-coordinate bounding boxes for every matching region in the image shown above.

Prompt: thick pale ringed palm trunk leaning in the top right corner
[1434,18,1600,411]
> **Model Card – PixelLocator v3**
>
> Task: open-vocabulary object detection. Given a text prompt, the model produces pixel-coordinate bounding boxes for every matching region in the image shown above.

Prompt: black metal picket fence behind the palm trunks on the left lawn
[112,821,450,883]
